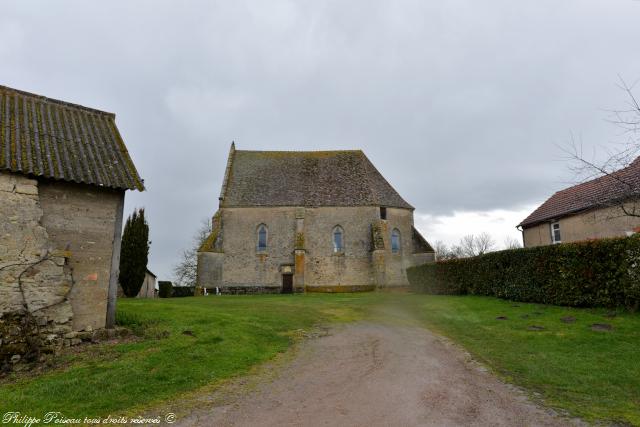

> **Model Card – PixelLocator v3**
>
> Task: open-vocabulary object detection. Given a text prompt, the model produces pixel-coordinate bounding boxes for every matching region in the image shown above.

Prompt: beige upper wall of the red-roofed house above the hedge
[523,204,640,247]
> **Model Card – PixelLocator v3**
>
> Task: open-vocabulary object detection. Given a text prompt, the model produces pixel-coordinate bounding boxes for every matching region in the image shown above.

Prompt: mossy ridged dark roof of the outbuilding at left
[0,86,144,191]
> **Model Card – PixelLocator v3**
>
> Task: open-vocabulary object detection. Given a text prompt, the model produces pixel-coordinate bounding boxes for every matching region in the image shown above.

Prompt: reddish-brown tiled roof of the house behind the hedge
[519,157,640,227]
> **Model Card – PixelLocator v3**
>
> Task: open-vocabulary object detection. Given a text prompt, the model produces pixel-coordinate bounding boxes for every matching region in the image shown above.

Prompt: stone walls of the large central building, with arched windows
[198,206,428,292]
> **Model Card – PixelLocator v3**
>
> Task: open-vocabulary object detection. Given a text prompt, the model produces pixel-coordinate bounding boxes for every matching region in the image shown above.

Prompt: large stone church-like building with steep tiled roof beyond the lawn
[197,144,434,293]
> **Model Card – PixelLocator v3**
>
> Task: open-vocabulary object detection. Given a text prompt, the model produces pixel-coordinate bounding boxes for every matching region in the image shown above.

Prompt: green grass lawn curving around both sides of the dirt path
[0,293,640,425]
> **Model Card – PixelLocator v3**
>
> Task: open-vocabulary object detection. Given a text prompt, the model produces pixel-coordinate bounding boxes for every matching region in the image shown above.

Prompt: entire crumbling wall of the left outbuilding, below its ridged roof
[0,172,124,368]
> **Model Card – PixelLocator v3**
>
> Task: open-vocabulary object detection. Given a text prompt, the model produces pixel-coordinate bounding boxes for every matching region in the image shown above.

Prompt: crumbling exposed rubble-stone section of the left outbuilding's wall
[0,172,73,364]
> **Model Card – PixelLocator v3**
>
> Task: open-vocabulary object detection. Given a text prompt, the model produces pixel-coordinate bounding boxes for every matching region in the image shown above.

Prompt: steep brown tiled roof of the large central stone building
[220,145,413,209]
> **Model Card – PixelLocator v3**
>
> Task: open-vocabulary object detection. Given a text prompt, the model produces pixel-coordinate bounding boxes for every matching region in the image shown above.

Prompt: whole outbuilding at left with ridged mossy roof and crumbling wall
[0,86,144,362]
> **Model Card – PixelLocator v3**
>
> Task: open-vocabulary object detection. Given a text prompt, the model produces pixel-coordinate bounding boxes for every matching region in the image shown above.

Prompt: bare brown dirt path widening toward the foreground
[178,323,569,426]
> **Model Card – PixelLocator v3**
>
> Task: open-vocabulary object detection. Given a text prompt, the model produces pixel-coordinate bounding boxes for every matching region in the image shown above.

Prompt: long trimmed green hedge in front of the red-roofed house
[407,235,640,309]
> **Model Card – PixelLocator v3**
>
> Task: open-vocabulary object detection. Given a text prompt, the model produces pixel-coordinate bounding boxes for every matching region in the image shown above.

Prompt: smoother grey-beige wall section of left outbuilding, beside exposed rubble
[39,181,124,331]
